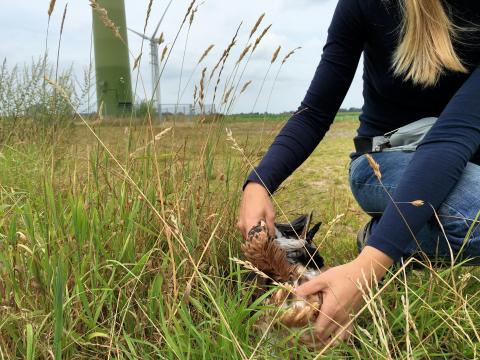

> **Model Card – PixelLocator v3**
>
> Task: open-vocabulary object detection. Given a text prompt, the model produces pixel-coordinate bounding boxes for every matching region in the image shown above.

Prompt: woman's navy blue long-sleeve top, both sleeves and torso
[247,0,480,261]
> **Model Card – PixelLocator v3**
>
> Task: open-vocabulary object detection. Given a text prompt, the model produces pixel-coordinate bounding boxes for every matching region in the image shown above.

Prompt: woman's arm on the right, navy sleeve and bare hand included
[297,68,480,342]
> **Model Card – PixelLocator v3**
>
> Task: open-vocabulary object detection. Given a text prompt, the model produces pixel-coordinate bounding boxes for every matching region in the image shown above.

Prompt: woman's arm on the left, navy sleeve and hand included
[238,0,367,236]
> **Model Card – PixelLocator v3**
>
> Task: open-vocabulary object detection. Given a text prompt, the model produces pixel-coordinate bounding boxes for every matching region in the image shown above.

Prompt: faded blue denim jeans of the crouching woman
[349,151,480,265]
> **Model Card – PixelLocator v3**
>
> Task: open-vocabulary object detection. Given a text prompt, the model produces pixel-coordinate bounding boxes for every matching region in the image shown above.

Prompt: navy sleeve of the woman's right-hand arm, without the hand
[367,64,480,261]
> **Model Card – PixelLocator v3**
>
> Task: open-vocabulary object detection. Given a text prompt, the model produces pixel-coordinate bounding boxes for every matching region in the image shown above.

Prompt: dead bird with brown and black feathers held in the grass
[241,214,326,348]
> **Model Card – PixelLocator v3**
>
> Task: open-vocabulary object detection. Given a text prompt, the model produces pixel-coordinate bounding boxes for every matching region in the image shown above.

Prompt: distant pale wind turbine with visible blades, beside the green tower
[128,0,173,118]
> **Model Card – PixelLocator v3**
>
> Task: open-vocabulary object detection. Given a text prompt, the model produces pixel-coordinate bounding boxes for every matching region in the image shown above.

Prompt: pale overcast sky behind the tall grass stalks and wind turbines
[0,0,363,112]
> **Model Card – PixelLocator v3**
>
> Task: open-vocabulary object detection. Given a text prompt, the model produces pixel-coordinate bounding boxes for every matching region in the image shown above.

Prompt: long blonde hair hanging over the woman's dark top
[393,0,467,87]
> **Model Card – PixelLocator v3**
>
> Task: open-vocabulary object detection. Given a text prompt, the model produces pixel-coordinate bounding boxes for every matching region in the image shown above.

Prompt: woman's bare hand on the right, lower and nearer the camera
[296,246,393,344]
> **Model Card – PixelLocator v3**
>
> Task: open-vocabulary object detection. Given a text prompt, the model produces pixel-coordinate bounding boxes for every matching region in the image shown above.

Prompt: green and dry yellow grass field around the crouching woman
[0,116,480,359]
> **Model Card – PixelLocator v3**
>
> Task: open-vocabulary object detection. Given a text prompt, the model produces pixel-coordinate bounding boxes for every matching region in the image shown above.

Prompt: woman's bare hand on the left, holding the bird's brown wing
[237,182,275,238]
